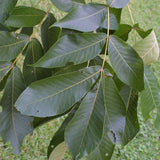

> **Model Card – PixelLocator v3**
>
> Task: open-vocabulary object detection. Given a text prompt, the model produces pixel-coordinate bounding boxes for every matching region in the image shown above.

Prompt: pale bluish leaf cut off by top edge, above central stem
[107,0,130,8]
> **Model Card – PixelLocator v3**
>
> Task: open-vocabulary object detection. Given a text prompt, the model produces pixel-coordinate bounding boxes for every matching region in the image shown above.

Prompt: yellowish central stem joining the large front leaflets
[101,7,110,72]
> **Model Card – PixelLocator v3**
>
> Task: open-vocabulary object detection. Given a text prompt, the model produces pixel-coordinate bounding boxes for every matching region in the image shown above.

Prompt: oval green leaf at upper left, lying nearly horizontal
[5,6,45,27]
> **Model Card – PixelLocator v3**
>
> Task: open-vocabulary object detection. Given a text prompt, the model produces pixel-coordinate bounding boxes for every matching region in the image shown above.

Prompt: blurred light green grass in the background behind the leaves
[0,0,160,160]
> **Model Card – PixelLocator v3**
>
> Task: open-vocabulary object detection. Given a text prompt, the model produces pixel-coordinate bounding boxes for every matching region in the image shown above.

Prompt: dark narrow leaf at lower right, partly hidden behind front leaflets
[121,85,139,145]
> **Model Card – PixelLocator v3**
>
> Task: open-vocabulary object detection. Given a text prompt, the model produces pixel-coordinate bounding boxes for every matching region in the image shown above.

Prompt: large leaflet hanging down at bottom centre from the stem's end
[65,82,105,159]
